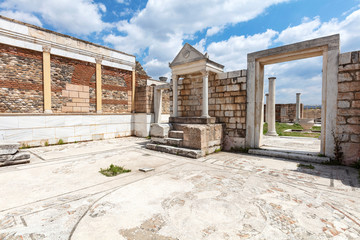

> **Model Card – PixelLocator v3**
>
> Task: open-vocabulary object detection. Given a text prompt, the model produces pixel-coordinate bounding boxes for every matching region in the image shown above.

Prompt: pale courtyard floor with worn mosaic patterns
[0,138,360,240]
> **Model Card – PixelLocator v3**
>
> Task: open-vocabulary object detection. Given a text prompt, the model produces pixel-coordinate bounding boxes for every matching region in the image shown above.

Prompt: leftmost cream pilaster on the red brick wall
[43,46,52,113]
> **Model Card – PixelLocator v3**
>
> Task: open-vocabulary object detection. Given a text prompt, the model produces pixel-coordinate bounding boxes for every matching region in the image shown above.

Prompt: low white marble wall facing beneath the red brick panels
[0,113,153,146]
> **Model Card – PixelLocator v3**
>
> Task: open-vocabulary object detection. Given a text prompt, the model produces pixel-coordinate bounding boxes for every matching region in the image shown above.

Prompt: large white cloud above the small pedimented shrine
[104,0,289,76]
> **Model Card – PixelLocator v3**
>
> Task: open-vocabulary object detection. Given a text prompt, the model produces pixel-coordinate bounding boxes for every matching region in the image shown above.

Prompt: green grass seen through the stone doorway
[263,122,321,138]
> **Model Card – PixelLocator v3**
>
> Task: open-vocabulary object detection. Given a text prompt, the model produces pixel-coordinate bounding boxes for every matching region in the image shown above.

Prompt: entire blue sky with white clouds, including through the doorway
[0,0,360,104]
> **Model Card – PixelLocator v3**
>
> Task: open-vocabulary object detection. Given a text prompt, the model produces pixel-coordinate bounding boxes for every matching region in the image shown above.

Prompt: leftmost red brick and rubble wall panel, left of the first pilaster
[0,44,43,113]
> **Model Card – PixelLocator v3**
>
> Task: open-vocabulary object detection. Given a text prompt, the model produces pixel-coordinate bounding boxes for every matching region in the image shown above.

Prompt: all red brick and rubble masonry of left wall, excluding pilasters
[0,44,142,113]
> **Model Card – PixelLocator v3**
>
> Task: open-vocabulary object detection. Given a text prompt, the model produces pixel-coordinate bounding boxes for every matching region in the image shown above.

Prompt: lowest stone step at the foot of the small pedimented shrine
[146,143,203,158]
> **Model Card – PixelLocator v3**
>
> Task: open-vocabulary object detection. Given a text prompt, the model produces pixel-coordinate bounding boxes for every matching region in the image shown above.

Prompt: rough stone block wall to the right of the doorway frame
[337,51,360,164]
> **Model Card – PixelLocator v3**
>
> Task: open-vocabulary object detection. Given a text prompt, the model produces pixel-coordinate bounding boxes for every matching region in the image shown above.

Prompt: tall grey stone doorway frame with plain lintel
[245,34,340,157]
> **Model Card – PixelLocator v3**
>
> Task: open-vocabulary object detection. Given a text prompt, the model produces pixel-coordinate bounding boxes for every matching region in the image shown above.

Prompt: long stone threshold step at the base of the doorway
[249,149,330,163]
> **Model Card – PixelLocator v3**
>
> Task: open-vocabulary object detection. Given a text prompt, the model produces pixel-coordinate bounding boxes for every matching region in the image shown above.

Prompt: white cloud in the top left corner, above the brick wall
[0,0,109,35]
